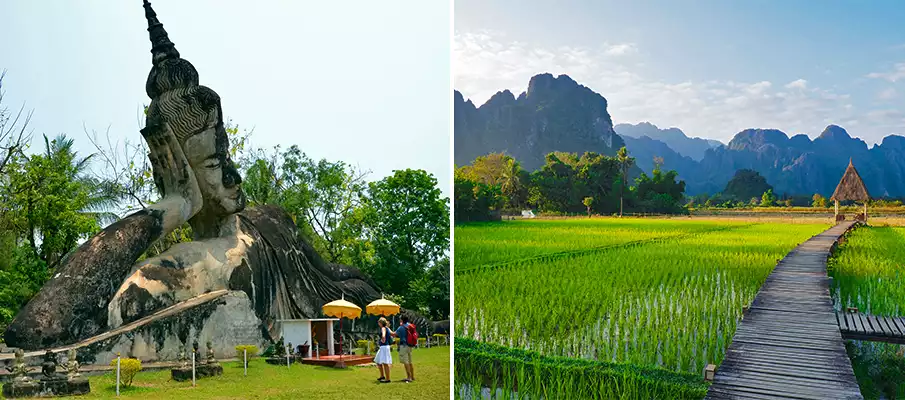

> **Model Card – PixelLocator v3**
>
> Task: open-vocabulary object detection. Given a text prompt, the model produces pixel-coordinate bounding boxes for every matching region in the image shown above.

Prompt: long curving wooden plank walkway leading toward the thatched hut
[706,221,863,399]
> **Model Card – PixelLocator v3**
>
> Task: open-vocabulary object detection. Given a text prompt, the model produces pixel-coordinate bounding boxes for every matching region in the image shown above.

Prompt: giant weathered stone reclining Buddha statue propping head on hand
[5,0,420,349]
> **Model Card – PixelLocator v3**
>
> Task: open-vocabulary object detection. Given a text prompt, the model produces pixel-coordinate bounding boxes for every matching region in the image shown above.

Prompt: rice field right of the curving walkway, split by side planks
[829,227,905,399]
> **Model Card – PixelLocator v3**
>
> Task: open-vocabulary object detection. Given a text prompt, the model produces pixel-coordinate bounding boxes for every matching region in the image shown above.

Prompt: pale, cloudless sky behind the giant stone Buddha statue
[0,0,451,196]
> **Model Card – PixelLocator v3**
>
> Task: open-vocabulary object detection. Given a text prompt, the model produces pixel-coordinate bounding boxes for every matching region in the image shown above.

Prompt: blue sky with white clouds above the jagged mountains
[453,0,905,143]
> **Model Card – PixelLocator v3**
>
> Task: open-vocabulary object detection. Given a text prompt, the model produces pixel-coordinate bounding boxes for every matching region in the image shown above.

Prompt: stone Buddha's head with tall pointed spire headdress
[144,0,245,219]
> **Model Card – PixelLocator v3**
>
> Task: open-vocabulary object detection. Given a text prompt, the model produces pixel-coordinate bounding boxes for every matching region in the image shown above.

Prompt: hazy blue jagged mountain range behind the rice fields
[454,74,905,197]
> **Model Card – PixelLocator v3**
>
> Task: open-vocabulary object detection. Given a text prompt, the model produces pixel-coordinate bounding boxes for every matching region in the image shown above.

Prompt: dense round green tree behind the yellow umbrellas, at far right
[362,169,449,309]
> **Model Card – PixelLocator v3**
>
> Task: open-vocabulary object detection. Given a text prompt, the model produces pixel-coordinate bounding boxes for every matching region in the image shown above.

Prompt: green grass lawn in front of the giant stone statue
[54,346,450,400]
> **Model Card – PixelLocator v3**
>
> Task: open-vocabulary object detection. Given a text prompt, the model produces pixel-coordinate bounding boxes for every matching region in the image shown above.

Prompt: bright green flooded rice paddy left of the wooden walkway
[455,218,828,398]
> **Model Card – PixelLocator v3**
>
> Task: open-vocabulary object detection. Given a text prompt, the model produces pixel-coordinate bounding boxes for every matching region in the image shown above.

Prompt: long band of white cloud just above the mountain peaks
[453,32,905,142]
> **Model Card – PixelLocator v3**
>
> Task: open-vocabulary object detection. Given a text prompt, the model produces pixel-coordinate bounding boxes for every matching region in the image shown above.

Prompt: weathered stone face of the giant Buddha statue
[182,126,245,216]
